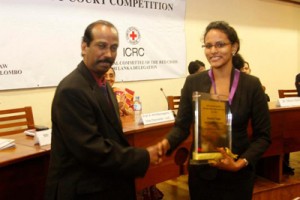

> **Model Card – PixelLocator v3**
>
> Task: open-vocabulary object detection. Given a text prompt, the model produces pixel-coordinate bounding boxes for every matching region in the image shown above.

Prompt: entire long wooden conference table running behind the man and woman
[0,102,300,200]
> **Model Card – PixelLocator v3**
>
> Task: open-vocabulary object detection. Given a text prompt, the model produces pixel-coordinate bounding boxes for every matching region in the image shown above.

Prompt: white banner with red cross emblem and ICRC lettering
[0,0,186,90]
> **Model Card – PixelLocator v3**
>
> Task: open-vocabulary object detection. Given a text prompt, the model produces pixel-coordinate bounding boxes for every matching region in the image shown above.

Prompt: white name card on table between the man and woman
[142,110,174,125]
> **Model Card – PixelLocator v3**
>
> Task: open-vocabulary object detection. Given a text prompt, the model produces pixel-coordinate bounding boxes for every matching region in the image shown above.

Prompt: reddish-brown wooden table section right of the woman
[257,102,300,183]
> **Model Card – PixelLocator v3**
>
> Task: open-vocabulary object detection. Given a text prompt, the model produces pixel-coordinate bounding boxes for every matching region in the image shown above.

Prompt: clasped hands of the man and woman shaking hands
[147,139,170,165]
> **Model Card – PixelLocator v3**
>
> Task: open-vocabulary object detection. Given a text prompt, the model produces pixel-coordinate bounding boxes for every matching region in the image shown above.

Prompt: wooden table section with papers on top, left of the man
[0,134,50,200]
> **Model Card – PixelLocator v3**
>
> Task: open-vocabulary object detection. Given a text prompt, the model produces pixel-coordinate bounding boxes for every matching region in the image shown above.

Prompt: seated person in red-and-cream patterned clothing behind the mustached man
[104,68,134,116]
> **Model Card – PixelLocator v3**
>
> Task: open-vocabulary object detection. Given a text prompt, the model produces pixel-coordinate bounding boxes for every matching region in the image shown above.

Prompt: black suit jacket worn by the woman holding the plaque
[167,70,271,179]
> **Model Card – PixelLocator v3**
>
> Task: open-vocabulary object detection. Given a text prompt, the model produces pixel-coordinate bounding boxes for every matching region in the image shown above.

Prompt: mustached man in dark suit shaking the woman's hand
[45,20,161,200]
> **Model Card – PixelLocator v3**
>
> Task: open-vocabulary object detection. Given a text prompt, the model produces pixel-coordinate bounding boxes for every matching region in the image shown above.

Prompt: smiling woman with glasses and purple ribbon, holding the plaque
[159,21,271,200]
